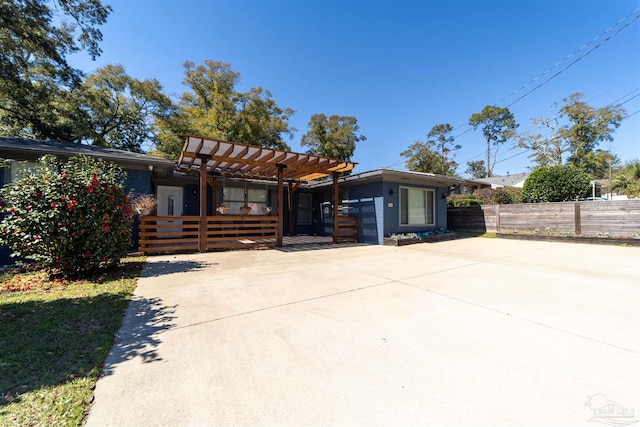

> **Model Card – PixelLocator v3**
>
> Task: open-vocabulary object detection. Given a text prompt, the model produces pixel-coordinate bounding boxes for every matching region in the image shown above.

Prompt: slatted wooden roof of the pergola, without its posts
[178,136,356,181]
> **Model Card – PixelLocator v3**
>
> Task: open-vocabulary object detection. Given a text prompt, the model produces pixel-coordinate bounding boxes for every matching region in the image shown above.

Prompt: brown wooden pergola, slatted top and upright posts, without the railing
[178,136,356,252]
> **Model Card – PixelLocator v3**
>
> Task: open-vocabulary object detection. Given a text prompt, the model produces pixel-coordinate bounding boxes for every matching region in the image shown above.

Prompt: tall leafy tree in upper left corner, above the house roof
[0,0,111,140]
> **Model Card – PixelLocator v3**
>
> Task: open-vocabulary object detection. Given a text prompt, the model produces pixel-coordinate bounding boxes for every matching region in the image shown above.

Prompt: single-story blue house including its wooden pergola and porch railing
[0,137,486,264]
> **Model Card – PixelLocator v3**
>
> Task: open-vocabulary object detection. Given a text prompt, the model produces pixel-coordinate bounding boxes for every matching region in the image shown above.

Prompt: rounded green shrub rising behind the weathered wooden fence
[522,165,591,203]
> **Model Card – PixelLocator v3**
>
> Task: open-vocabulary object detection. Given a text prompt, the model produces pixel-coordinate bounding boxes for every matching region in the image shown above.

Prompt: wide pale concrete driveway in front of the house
[88,238,640,426]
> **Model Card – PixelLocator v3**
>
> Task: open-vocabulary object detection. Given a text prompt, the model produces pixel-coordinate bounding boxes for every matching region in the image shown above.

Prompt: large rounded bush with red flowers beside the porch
[0,155,132,277]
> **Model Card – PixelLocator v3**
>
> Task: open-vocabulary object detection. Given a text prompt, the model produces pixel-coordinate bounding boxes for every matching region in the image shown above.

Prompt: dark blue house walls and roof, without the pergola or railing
[0,137,489,264]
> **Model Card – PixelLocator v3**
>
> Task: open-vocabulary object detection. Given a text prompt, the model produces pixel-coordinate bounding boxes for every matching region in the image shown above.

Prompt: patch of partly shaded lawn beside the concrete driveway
[0,258,145,426]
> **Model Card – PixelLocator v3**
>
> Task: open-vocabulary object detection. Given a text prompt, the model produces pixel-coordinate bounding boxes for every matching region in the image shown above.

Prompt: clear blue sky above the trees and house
[67,0,640,175]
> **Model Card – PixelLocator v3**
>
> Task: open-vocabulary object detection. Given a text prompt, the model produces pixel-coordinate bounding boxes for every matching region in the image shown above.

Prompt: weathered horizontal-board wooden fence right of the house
[447,200,640,238]
